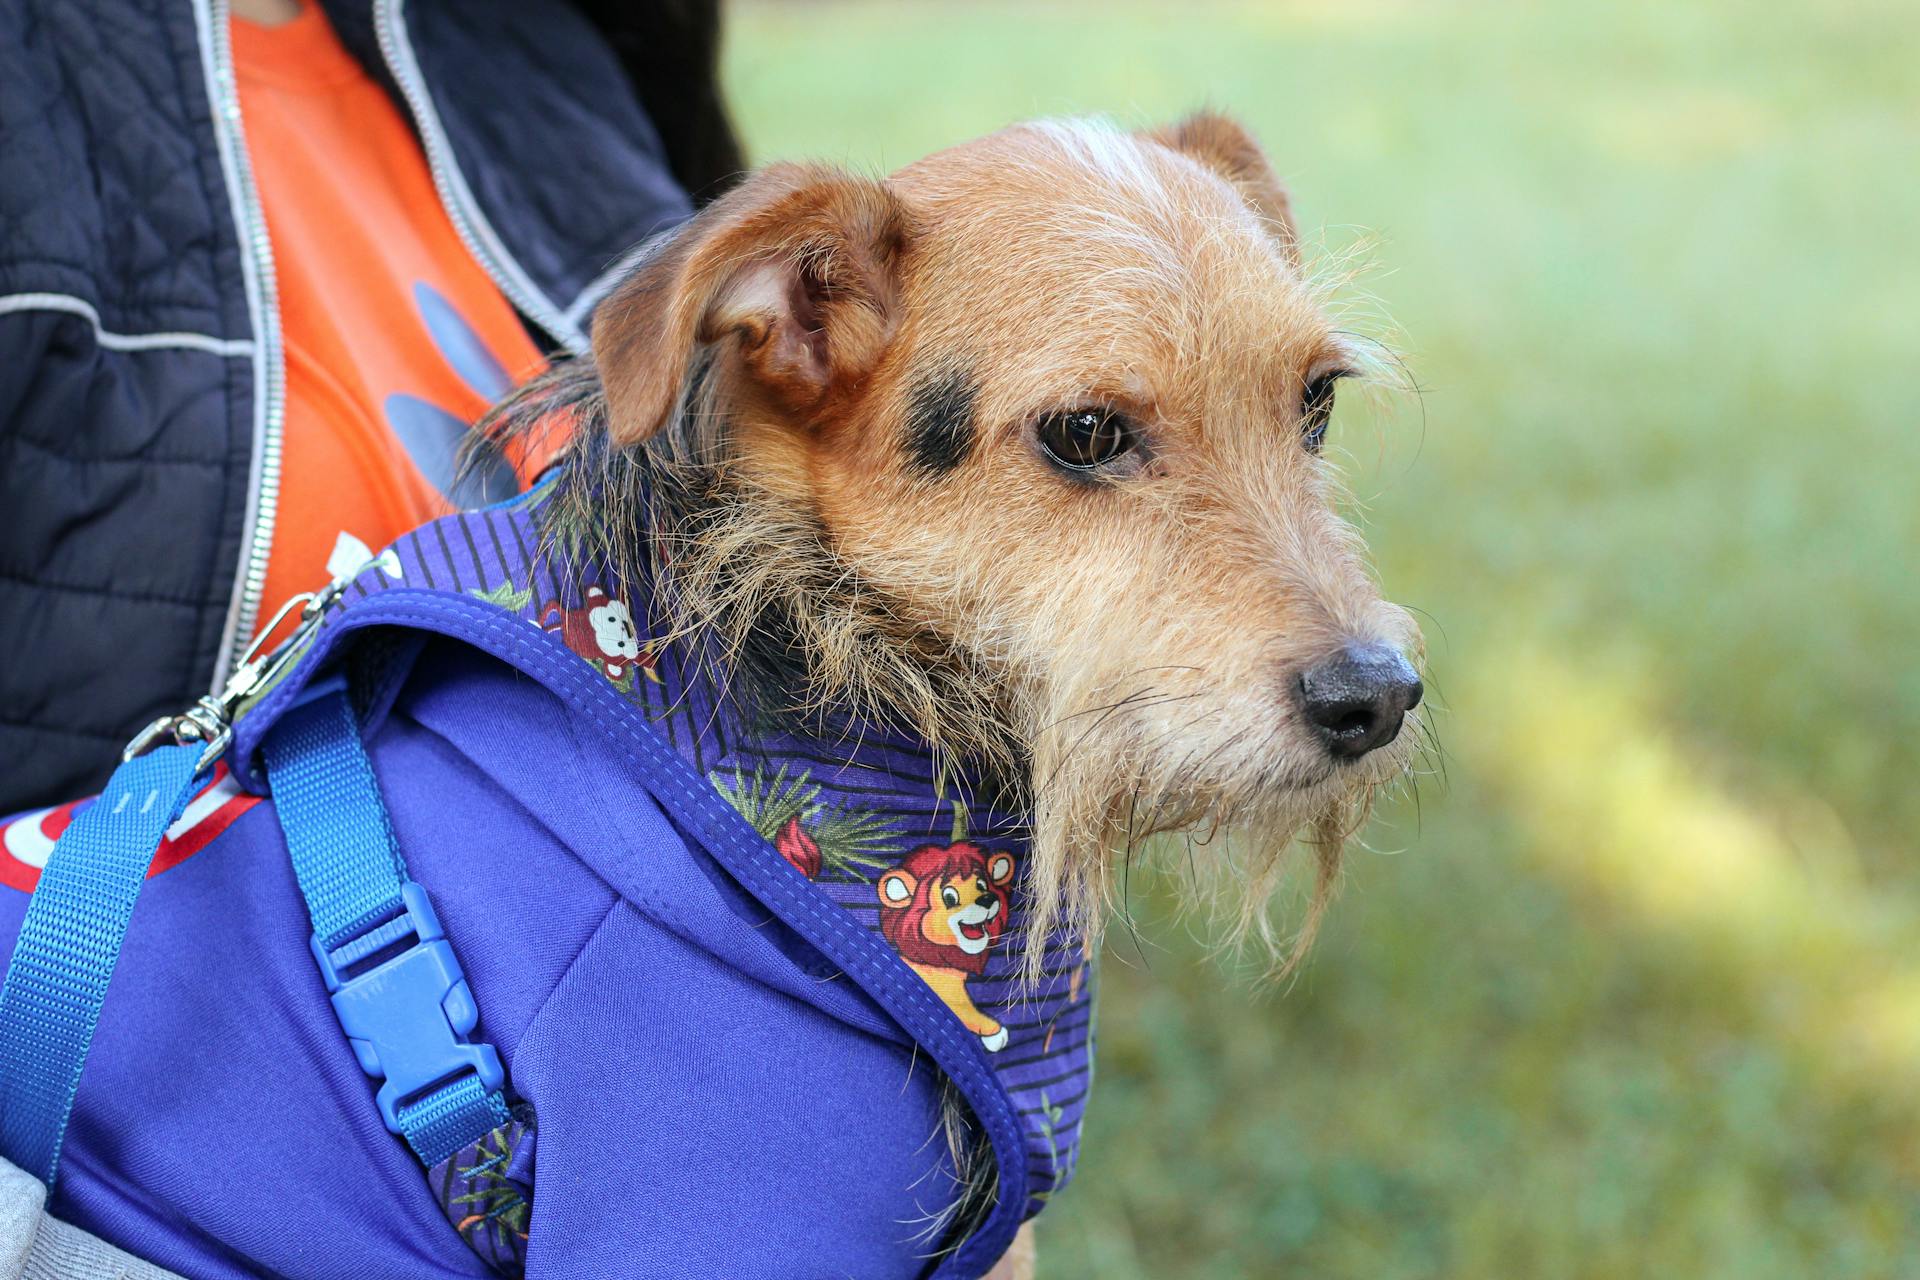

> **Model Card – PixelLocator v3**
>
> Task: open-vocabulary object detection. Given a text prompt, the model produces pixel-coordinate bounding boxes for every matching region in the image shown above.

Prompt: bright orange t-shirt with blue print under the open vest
[232,0,541,652]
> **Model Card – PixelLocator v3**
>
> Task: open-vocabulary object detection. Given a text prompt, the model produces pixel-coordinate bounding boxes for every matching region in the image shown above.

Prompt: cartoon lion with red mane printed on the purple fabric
[876,841,1014,1054]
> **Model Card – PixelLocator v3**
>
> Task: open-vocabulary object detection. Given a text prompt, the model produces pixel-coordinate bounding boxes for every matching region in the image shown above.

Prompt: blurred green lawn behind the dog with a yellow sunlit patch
[730,0,1920,1280]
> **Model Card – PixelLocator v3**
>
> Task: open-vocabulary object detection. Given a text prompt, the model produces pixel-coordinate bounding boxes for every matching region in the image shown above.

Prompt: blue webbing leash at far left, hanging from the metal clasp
[0,743,207,1188]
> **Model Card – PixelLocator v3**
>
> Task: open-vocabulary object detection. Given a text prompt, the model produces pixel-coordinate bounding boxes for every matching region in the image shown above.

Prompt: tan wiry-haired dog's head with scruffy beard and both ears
[576,115,1421,971]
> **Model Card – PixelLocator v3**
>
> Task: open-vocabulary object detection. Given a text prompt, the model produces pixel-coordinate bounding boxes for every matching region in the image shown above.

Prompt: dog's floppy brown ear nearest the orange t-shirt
[593,165,908,445]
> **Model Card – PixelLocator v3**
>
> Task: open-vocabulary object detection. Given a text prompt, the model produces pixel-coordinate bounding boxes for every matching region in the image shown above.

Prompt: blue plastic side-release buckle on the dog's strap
[311,881,507,1134]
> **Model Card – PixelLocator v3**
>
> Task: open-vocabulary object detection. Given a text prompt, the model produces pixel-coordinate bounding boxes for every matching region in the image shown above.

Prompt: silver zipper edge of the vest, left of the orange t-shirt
[194,0,286,689]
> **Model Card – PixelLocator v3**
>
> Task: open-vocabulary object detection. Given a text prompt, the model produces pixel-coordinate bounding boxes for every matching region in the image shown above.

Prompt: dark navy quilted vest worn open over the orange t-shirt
[0,0,689,808]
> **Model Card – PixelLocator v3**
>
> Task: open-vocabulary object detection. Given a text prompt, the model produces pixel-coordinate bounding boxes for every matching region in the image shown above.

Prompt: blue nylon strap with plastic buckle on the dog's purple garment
[263,677,509,1169]
